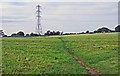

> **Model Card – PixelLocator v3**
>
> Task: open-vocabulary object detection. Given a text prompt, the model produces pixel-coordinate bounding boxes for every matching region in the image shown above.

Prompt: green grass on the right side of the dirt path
[63,33,119,74]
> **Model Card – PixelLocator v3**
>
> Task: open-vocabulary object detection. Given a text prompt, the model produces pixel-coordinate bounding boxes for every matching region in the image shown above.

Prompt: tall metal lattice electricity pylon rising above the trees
[37,5,42,35]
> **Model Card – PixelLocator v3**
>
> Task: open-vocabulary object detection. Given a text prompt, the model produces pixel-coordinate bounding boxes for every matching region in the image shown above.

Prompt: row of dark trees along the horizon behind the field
[0,25,120,37]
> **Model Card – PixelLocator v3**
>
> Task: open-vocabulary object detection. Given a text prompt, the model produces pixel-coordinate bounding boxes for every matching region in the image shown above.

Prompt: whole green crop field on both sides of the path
[2,33,120,74]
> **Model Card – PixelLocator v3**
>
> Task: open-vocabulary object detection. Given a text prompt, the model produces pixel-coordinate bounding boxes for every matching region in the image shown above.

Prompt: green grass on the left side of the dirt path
[2,37,88,74]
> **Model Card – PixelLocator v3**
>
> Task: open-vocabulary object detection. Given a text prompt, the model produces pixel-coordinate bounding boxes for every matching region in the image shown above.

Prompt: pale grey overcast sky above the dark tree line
[0,0,118,35]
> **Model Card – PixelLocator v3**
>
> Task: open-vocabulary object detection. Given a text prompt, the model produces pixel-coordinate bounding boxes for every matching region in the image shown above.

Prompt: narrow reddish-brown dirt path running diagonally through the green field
[59,37,99,76]
